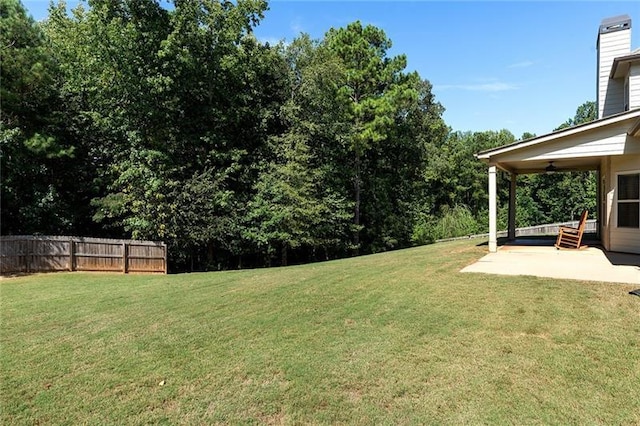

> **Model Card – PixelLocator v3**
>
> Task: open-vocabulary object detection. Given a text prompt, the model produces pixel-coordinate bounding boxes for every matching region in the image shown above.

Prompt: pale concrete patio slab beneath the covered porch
[460,242,640,284]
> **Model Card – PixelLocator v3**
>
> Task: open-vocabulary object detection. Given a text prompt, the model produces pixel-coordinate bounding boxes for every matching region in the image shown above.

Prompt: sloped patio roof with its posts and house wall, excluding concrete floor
[476,109,640,254]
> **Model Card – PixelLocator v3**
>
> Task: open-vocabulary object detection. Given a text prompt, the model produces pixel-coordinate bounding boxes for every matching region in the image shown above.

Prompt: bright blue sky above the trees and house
[23,0,640,137]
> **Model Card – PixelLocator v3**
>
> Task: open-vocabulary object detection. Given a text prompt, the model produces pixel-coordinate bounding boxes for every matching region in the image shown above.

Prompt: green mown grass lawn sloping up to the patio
[0,240,640,424]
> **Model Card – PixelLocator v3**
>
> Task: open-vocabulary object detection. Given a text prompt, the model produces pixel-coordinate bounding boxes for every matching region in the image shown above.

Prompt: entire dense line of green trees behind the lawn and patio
[0,0,595,270]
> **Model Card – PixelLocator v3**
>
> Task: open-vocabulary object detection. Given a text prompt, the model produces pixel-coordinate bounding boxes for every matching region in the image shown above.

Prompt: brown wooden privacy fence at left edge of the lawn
[0,235,167,274]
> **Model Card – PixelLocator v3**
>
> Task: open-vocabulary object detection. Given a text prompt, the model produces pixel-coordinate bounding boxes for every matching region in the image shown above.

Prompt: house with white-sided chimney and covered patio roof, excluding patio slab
[476,15,640,254]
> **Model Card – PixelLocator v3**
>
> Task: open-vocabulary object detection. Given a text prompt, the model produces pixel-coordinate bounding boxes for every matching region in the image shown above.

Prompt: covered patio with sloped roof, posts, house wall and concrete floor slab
[462,109,640,284]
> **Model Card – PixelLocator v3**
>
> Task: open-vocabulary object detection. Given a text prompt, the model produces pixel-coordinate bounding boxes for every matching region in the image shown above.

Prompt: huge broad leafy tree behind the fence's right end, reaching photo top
[47,0,283,261]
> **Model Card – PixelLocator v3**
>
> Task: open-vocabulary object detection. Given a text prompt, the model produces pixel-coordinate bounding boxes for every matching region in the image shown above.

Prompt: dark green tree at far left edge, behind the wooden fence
[0,0,82,234]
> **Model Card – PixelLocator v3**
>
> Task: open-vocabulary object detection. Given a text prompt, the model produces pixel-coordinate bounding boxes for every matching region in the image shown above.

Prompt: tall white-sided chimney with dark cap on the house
[596,15,631,118]
